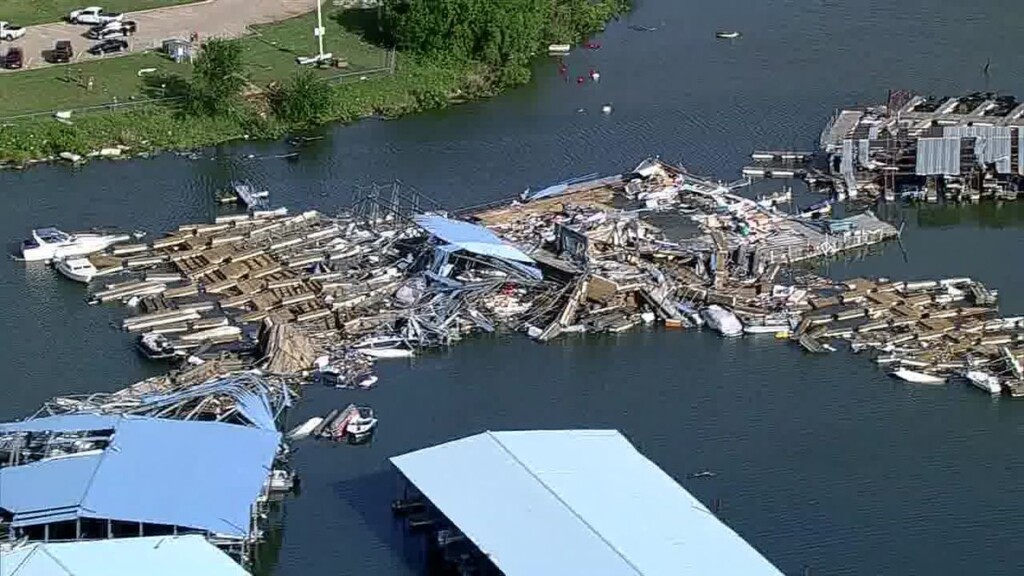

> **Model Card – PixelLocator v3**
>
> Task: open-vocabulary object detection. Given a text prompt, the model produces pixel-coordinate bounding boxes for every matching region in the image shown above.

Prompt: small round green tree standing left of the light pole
[187,39,249,116]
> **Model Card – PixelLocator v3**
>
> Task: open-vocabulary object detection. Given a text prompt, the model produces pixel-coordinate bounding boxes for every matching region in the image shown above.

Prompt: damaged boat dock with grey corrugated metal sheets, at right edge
[820,90,1024,202]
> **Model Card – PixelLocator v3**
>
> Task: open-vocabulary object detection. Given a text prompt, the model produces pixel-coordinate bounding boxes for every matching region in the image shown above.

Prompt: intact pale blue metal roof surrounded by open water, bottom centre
[391,430,782,576]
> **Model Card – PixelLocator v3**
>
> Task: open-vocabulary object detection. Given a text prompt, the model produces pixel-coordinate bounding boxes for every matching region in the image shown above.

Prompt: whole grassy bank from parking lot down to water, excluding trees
[0,0,620,164]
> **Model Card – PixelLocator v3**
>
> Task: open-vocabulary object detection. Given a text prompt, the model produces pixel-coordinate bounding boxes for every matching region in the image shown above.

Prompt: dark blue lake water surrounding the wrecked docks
[0,0,1024,576]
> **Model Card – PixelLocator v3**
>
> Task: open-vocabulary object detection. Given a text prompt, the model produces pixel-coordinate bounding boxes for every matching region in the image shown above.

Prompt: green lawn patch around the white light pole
[241,12,385,84]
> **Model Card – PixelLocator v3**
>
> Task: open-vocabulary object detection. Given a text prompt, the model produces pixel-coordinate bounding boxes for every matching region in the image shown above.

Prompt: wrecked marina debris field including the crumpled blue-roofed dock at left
[0,150,1024,567]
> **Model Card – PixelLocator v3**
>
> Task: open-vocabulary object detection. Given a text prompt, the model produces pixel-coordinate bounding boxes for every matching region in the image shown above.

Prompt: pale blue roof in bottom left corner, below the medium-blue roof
[0,534,249,576]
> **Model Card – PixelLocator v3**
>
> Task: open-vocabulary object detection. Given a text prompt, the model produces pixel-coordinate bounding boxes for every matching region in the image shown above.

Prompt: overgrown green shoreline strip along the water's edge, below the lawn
[0,0,628,169]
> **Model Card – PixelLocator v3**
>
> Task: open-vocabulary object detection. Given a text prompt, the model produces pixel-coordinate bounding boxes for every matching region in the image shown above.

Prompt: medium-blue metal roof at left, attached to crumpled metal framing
[0,415,281,537]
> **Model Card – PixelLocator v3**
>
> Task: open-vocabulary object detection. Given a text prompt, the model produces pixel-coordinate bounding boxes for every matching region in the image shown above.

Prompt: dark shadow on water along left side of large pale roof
[332,466,429,574]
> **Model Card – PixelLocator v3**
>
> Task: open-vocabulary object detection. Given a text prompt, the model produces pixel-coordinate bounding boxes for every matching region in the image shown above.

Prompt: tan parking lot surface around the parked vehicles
[0,0,315,72]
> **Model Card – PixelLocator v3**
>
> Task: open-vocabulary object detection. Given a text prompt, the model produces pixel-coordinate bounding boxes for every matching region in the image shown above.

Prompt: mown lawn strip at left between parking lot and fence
[0,52,189,118]
